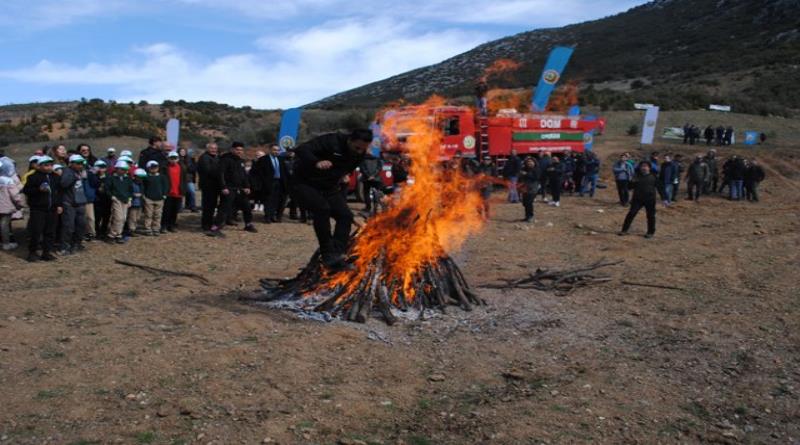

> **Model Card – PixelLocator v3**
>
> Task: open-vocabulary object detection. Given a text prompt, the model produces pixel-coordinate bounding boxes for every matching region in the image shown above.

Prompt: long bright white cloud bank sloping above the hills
[0,21,485,108]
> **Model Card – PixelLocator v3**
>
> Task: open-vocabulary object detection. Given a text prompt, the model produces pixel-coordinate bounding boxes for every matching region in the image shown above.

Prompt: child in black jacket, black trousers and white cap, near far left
[22,156,62,262]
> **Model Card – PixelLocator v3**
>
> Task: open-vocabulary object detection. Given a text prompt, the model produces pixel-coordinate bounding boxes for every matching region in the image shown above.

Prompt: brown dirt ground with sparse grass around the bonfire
[0,140,800,445]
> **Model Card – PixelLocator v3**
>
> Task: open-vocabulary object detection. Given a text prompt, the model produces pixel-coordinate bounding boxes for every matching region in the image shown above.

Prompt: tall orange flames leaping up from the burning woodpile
[325,97,483,304]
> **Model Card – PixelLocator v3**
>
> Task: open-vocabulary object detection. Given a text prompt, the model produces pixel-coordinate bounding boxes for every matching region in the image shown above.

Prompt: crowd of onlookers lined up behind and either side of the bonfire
[0,134,776,261]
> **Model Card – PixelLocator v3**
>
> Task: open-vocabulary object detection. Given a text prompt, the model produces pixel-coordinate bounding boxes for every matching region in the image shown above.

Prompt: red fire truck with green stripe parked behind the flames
[383,106,605,160]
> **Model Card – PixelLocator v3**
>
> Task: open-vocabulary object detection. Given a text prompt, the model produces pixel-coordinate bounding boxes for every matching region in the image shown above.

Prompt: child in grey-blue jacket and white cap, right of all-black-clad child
[59,155,87,255]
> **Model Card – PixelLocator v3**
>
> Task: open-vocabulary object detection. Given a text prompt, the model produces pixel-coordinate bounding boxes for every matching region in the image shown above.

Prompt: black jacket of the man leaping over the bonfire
[293,133,364,190]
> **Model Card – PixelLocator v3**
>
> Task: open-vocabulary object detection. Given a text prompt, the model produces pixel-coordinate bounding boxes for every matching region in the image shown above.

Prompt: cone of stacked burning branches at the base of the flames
[258,248,485,325]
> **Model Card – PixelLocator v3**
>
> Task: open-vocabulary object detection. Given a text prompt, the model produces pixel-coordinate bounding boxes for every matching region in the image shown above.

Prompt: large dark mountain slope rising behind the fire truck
[310,0,800,116]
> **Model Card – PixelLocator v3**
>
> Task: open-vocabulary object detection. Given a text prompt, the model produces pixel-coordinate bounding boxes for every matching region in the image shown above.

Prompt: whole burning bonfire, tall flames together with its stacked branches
[262,98,483,324]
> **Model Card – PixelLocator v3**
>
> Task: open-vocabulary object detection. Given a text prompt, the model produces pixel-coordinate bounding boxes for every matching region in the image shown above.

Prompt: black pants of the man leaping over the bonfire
[292,184,353,254]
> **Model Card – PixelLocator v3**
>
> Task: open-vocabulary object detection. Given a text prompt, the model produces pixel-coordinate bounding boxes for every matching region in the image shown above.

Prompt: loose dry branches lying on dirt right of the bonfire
[481,259,624,295]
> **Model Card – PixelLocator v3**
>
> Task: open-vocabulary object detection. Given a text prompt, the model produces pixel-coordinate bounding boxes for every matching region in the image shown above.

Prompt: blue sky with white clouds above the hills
[0,0,645,109]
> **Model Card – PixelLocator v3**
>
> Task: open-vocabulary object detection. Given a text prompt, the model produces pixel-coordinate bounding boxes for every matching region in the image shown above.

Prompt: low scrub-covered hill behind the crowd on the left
[0,99,372,148]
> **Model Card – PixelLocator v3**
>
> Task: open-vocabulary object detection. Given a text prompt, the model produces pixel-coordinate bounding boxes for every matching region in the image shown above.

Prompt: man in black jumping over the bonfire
[292,129,372,269]
